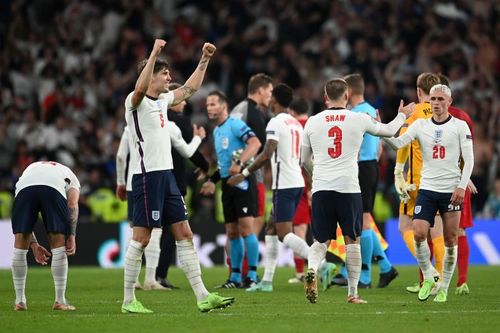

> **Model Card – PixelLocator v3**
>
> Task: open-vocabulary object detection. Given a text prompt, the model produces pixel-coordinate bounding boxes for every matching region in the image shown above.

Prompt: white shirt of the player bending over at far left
[15,161,80,198]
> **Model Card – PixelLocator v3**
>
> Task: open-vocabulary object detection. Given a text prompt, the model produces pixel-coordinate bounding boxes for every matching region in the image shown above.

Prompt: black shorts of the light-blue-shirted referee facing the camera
[222,175,258,223]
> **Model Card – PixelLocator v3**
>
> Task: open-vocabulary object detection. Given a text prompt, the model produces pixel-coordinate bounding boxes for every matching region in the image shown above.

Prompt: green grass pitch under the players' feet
[0,266,500,333]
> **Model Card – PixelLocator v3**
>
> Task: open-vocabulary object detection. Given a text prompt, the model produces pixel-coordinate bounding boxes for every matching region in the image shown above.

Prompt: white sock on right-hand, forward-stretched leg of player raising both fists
[175,239,209,301]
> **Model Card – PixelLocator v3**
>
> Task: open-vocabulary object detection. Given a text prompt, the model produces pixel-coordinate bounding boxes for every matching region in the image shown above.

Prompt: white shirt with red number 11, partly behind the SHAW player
[266,113,304,190]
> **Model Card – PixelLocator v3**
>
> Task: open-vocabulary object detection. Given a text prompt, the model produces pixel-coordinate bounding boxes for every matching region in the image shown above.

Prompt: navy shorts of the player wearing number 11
[271,187,304,223]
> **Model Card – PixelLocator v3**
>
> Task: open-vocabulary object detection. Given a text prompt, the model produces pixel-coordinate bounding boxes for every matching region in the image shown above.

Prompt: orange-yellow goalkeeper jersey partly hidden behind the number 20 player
[396,102,432,187]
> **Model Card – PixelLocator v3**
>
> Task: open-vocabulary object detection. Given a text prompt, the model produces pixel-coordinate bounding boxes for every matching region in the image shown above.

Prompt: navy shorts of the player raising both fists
[132,170,187,228]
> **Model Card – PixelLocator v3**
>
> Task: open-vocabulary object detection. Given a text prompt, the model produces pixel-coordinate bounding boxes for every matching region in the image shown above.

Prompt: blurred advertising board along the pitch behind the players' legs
[0,220,500,268]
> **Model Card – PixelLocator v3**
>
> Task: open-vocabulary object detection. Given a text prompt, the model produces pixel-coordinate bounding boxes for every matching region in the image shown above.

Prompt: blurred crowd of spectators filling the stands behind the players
[0,0,500,222]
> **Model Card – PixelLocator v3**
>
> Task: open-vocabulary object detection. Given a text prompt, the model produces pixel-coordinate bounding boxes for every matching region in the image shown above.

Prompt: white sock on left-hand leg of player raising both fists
[123,239,144,303]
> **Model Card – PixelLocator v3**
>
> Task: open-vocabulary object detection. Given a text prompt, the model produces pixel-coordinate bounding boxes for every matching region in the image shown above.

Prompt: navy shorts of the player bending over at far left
[12,185,70,235]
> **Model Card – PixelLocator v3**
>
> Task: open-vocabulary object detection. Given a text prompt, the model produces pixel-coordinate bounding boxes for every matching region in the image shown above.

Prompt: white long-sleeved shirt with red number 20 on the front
[389,116,474,193]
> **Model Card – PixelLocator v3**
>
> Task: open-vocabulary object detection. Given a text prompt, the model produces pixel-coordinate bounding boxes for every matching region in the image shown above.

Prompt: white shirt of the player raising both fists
[125,91,174,174]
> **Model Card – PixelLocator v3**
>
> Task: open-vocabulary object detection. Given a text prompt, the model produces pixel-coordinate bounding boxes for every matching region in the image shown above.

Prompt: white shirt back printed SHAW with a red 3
[304,109,376,193]
